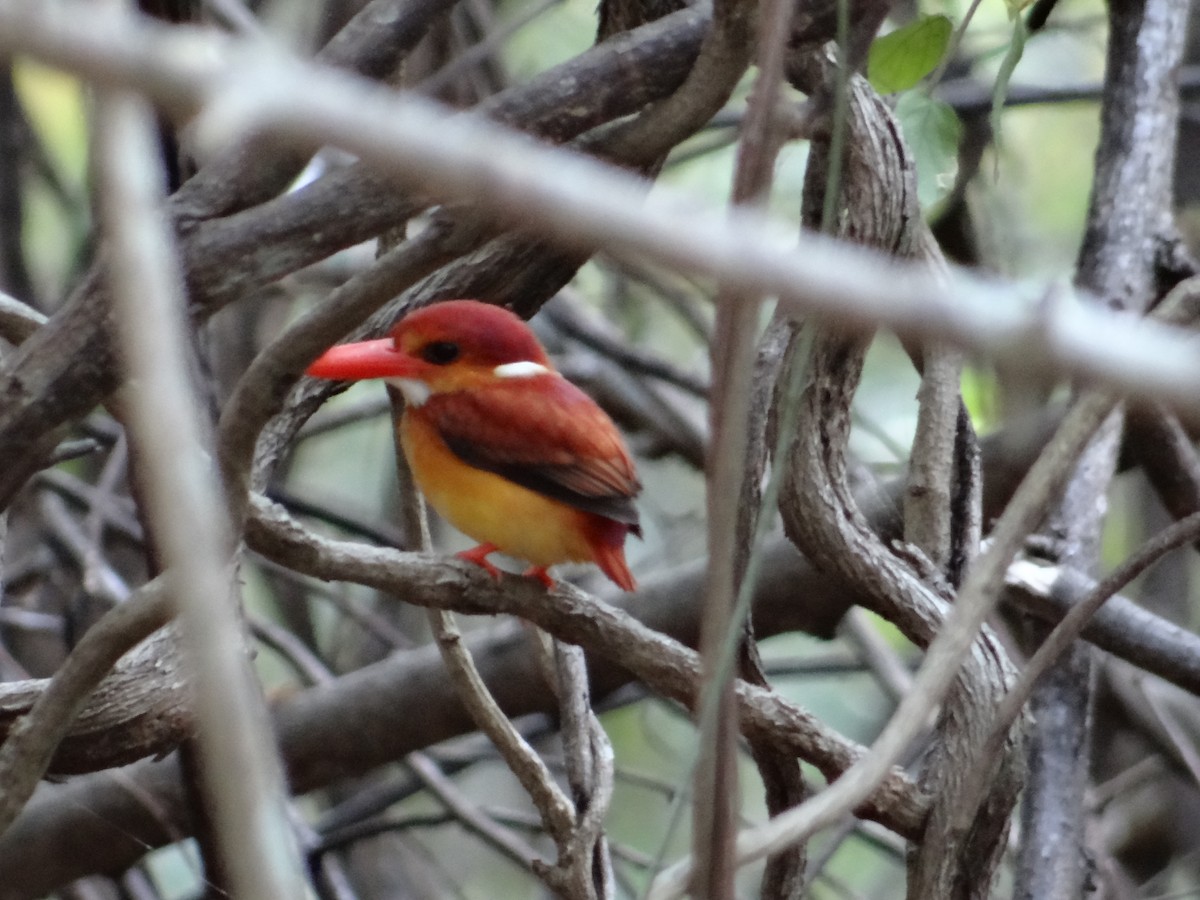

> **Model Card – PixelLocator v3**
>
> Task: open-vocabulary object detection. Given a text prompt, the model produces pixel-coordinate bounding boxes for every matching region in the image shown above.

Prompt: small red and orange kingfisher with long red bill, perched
[307,300,642,592]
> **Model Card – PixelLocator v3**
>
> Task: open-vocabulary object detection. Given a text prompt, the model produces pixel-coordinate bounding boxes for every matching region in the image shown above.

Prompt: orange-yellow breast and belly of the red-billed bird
[400,409,595,565]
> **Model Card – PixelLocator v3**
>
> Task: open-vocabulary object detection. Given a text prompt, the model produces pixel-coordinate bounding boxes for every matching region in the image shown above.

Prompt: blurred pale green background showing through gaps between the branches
[0,0,1200,900]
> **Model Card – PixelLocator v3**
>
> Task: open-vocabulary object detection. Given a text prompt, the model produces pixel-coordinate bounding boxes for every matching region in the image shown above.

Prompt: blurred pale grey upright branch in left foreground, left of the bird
[97,86,305,900]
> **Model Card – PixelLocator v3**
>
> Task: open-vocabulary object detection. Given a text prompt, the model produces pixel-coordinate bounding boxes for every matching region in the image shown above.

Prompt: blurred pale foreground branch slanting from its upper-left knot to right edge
[187,61,1200,413]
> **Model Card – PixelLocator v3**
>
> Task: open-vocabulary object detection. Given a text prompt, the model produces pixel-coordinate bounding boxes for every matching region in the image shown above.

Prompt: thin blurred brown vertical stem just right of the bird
[691,0,782,899]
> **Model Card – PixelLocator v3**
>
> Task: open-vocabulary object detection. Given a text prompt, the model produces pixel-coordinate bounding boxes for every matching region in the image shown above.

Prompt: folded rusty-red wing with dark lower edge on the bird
[419,374,642,533]
